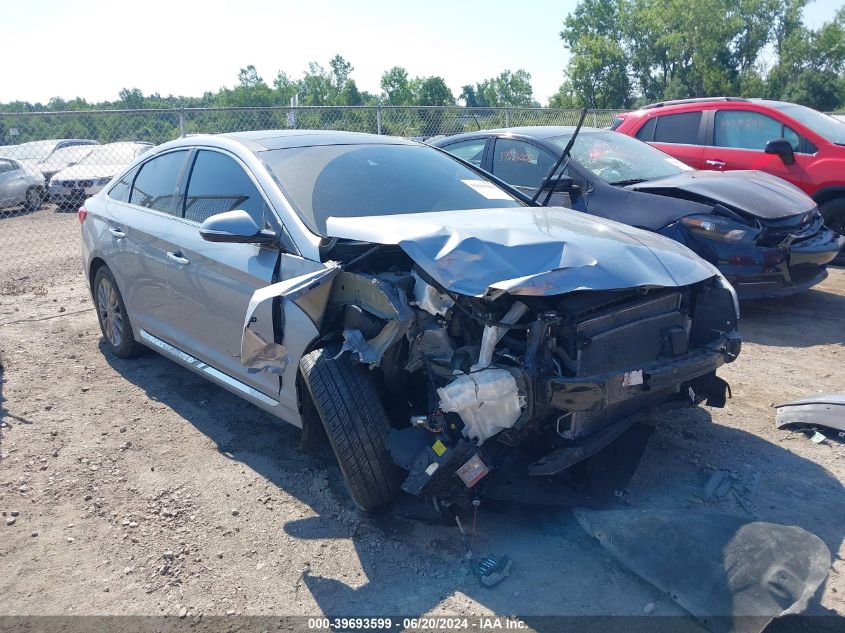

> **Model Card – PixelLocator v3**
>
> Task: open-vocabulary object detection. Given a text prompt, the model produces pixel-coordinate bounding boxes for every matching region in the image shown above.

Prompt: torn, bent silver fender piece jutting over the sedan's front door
[241,262,340,374]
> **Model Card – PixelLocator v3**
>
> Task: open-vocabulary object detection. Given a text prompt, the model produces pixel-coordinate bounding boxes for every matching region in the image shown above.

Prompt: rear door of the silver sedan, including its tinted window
[100,150,189,339]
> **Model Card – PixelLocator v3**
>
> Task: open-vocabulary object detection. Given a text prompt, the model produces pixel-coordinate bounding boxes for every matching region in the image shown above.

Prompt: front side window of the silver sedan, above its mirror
[185,150,266,228]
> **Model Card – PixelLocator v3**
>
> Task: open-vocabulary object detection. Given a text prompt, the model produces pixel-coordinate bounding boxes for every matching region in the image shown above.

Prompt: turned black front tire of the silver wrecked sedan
[299,348,400,512]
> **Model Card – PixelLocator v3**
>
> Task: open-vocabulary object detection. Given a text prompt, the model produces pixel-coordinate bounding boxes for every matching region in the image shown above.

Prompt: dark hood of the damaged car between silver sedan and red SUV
[628,170,816,220]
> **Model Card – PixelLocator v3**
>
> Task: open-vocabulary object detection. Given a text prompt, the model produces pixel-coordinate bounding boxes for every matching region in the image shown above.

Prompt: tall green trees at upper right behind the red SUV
[550,0,845,111]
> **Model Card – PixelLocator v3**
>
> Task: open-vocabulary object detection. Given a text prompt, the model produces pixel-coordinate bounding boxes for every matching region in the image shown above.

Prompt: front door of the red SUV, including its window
[704,108,812,190]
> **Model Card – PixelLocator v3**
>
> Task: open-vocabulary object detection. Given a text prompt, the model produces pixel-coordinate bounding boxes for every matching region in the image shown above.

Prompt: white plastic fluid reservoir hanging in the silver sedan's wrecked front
[437,368,522,446]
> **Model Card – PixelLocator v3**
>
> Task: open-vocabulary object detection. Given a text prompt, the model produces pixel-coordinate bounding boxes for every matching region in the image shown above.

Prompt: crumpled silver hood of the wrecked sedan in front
[326,207,719,297]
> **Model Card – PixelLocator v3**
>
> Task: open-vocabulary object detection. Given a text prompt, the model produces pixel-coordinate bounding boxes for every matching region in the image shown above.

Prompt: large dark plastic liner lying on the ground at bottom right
[575,509,830,633]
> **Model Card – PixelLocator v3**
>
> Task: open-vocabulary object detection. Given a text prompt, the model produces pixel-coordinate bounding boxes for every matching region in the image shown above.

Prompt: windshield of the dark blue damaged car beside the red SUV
[552,131,692,185]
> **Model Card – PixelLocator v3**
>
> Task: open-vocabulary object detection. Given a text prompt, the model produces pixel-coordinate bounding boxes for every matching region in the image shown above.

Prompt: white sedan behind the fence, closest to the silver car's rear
[49,141,153,208]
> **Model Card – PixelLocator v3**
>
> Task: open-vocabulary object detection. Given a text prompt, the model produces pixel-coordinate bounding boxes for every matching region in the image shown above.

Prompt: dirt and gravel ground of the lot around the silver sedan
[0,211,845,628]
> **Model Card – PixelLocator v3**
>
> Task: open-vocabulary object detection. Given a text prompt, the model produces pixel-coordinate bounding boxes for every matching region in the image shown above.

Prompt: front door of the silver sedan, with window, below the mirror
[162,148,280,399]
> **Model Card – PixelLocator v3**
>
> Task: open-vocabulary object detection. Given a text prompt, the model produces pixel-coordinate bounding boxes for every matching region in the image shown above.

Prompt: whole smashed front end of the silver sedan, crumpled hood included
[244,209,740,504]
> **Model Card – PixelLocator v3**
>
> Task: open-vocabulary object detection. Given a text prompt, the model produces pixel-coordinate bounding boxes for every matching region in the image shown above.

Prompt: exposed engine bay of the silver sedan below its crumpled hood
[288,239,740,502]
